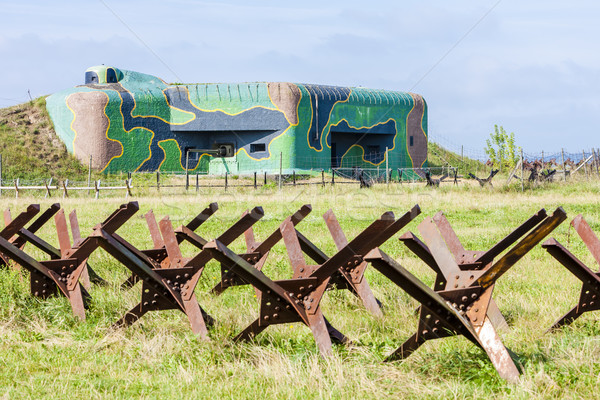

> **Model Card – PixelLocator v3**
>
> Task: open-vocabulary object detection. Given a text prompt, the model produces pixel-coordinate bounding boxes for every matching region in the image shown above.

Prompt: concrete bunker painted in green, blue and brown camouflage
[46,66,427,174]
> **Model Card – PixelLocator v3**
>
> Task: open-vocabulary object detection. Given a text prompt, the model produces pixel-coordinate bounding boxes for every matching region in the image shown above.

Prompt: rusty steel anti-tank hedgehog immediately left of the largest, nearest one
[204,206,420,356]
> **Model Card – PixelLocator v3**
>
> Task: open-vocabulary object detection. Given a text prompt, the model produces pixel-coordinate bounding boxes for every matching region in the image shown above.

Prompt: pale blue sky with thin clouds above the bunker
[0,0,600,155]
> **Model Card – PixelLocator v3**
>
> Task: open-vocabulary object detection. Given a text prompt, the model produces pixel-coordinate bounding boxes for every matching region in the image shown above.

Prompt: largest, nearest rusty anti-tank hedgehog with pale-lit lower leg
[366,208,566,382]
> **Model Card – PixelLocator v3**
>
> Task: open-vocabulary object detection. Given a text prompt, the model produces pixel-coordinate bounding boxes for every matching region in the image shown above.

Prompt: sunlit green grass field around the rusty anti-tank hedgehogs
[0,182,600,399]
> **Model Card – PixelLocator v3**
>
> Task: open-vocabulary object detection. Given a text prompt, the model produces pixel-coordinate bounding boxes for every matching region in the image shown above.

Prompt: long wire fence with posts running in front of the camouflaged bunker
[0,141,600,199]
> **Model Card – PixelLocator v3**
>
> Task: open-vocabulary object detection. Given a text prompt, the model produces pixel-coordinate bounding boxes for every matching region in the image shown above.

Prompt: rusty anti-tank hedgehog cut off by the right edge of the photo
[542,214,600,330]
